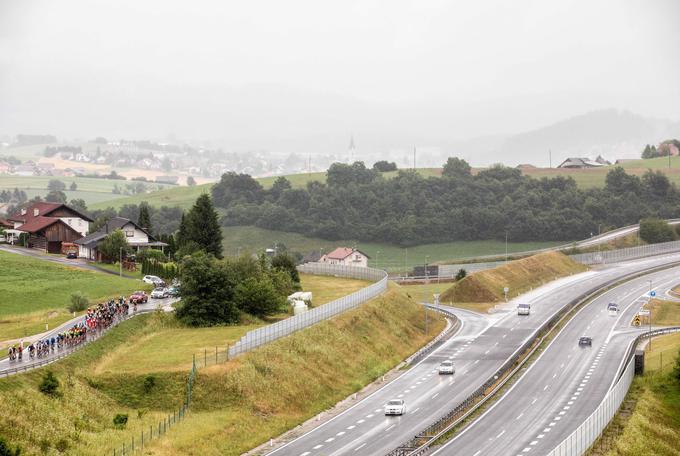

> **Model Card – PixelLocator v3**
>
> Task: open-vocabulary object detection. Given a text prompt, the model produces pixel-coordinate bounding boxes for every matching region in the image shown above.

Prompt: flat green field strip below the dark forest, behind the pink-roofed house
[222,226,563,271]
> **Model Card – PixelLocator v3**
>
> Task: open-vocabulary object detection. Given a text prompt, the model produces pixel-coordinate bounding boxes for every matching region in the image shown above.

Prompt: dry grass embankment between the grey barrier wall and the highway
[138,285,444,455]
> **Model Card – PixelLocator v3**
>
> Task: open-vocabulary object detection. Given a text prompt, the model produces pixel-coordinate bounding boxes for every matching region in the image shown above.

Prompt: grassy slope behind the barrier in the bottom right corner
[587,334,680,456]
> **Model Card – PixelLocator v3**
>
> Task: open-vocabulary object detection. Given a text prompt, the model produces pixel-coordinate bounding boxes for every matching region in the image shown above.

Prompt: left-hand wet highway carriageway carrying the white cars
[269,254,680,456]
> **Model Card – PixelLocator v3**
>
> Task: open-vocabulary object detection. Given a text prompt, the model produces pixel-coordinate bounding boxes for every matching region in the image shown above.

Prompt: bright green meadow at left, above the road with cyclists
[0,252,149,341]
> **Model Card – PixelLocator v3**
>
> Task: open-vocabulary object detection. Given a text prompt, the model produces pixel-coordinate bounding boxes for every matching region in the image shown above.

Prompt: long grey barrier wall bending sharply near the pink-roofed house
[229,263,387,358]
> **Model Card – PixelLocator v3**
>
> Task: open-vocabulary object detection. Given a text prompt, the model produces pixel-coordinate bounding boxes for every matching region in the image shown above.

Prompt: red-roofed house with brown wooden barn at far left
[7,202,92,253]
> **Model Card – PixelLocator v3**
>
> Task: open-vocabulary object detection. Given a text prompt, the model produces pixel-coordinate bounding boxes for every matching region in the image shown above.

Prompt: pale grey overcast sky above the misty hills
[0,0,680,151]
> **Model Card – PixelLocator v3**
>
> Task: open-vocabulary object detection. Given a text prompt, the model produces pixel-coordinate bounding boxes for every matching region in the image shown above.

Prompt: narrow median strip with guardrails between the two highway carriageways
[386,262,678,456]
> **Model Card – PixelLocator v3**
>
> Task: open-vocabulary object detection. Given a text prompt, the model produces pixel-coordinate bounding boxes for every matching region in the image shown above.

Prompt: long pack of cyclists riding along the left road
[7,296,137,361]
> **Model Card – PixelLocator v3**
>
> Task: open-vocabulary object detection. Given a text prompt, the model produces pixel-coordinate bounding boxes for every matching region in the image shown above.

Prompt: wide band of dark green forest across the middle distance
[212,158,680,246]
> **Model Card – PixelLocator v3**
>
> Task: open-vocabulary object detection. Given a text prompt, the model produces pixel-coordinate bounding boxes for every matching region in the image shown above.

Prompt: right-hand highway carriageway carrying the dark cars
[432,267,680,456]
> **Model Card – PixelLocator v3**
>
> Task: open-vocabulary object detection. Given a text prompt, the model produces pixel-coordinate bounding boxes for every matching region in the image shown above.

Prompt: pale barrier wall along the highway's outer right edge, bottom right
[547,326,680,456]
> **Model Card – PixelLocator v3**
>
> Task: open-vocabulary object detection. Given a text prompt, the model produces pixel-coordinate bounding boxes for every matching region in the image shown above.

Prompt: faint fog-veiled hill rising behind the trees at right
[485,109,680,167]
